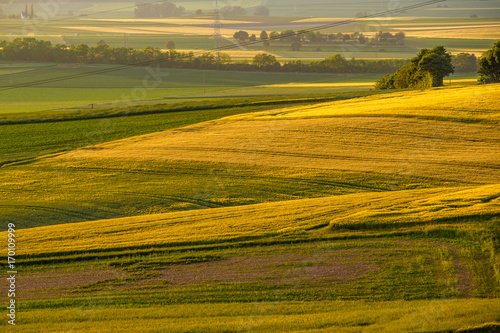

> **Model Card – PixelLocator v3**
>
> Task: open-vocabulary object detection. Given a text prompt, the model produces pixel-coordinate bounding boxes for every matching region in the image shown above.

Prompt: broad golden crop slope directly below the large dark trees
[59,85,500,183]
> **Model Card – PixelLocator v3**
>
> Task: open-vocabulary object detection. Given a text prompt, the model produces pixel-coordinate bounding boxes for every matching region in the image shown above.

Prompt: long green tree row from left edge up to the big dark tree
[0,37,407,73]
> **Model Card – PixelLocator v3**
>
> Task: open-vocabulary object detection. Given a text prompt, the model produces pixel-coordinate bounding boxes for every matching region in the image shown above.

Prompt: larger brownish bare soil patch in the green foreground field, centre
[139,251,377,286]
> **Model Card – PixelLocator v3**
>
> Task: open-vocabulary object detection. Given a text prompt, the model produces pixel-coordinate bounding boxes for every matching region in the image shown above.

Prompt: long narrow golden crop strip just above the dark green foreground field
[12,185,500,254]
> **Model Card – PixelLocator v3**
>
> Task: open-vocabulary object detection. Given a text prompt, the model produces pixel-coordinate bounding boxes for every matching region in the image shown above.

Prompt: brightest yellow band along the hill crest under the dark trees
[231,84,500,123]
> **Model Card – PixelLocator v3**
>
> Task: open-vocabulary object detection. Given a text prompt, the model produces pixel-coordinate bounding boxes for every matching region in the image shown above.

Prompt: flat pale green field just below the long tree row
[0,62,394,114]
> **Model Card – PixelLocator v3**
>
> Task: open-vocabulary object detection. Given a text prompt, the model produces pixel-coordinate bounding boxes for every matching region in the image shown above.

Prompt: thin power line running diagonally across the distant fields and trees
[0,0,446,91]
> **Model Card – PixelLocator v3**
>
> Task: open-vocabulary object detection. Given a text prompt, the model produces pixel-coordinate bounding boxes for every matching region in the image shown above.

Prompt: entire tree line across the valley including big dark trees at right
[0,37,500,79]
